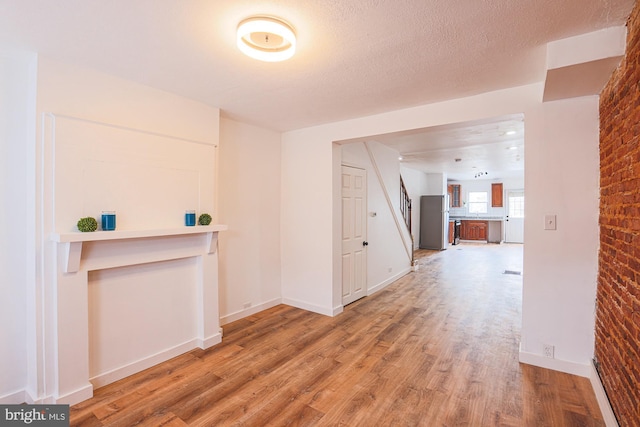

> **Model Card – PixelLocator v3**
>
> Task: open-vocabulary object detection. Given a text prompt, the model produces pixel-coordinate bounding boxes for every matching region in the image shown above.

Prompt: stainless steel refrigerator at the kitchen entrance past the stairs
[419,196,449,250]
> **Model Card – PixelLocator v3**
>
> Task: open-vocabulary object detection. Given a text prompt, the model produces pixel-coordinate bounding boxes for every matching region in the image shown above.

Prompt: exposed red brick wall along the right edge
[595,4,640,426]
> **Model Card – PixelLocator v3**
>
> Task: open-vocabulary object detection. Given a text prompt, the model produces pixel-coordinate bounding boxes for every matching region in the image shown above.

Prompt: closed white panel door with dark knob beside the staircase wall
[342,166,368,305]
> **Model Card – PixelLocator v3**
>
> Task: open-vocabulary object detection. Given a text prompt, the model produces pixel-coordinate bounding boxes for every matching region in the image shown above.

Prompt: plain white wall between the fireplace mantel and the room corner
[219,118,282,325]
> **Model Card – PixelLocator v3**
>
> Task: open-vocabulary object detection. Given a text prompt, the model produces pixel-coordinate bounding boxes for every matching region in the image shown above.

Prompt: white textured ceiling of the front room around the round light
[0,0,634,131]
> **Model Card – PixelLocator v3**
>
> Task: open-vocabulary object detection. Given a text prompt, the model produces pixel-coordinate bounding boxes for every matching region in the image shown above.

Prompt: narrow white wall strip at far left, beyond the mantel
[0,52,36,403]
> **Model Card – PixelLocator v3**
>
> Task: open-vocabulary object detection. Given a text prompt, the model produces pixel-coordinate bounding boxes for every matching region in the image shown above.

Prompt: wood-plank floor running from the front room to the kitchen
[71,244,604,427]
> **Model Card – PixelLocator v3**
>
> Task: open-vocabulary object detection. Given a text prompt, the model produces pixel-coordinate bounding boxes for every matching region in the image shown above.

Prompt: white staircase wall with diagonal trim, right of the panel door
[342,142,411,295]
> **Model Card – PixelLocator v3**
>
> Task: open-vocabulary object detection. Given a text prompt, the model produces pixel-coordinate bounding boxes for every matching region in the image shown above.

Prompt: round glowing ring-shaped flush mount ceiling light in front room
[237,16,296,62]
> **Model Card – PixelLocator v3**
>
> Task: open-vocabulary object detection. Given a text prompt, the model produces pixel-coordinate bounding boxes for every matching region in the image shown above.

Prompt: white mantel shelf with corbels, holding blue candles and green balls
[50,224,228,273]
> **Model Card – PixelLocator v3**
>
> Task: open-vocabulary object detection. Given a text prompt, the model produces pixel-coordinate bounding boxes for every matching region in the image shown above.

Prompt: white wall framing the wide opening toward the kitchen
[282,84,598,378]
